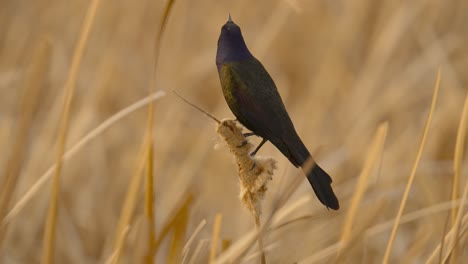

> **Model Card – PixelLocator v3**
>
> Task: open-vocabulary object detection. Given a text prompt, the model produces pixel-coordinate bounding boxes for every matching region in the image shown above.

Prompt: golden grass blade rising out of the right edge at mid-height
[452,96,468,224]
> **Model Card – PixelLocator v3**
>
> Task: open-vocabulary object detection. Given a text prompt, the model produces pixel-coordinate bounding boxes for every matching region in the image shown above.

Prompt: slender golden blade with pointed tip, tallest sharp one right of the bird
[382,69,440,264]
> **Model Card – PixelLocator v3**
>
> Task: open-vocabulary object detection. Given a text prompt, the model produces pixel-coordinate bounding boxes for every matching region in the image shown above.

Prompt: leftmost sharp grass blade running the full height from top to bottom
[42,0,100,263]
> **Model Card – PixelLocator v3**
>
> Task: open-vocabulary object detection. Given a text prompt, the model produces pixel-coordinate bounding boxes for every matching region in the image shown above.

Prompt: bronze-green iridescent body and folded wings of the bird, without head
[221,59,309,166]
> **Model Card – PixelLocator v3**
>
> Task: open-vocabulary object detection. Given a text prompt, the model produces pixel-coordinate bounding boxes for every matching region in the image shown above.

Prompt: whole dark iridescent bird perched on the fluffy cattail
[216,16,340,210]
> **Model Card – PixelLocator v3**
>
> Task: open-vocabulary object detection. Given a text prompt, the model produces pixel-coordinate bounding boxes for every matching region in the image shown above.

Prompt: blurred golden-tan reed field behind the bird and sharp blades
[0,0,468,263]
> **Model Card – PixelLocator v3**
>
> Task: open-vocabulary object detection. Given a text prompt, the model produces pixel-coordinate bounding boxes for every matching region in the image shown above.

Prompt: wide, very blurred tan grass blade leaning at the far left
[0,41,51,247]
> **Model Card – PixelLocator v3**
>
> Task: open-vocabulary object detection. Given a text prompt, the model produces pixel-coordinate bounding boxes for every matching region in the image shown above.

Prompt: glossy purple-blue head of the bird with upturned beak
[216,15,253,69]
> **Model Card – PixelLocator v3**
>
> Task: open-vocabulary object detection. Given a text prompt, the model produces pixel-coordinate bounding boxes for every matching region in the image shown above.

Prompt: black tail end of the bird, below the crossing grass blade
[306,164,340,210]
